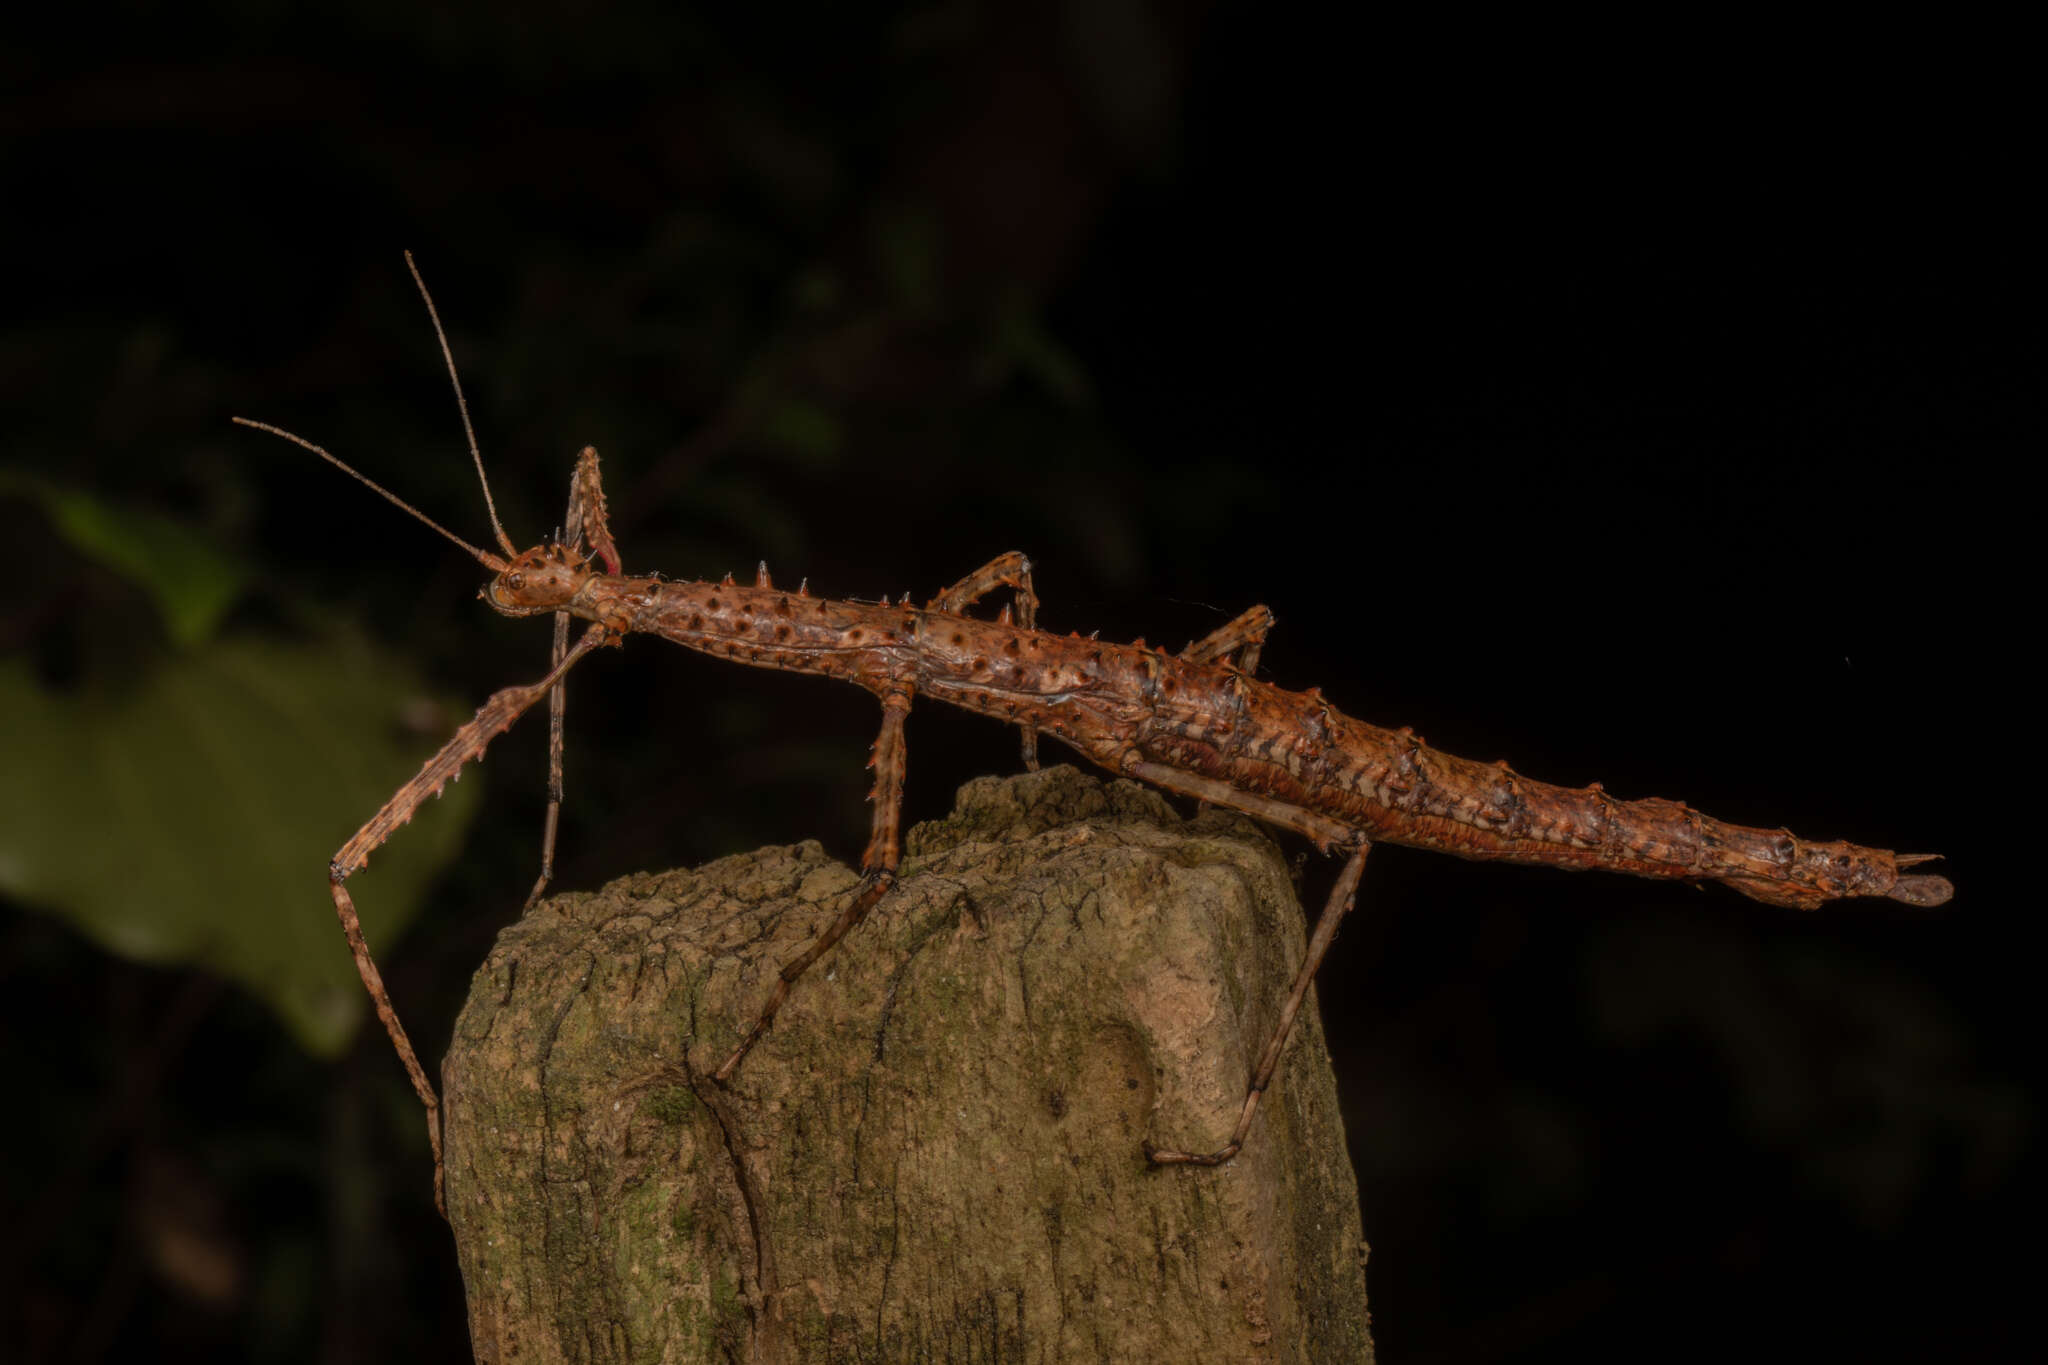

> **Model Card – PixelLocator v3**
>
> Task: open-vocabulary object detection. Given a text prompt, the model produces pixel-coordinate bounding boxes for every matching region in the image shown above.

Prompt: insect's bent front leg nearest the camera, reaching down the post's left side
[328,626,608,1214]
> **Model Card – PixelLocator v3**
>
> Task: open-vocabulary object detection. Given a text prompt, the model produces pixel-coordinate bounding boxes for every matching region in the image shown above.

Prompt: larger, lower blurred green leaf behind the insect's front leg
[0,639,475,1056]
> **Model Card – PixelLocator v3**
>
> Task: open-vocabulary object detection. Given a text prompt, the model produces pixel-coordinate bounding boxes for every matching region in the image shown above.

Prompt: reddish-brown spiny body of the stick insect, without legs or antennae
[487,551,1950,909]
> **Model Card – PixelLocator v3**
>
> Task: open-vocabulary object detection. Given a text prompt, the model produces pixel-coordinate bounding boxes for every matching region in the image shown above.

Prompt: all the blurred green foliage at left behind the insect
[0,471,475,1056]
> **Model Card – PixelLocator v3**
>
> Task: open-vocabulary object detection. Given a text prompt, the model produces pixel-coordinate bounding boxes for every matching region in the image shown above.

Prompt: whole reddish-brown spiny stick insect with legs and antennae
[236,254,1952,1212]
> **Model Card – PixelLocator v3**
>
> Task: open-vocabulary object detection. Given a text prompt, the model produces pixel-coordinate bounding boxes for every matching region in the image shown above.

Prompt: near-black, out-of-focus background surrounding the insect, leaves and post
[0,0,2040,1363]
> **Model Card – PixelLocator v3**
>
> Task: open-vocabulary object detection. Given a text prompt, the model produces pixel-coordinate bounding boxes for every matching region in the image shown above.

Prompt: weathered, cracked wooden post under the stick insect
[442,767,1372,1363]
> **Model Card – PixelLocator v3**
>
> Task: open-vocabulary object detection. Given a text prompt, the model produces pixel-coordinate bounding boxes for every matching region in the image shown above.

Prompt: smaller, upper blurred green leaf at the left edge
[0,471,248,647]
